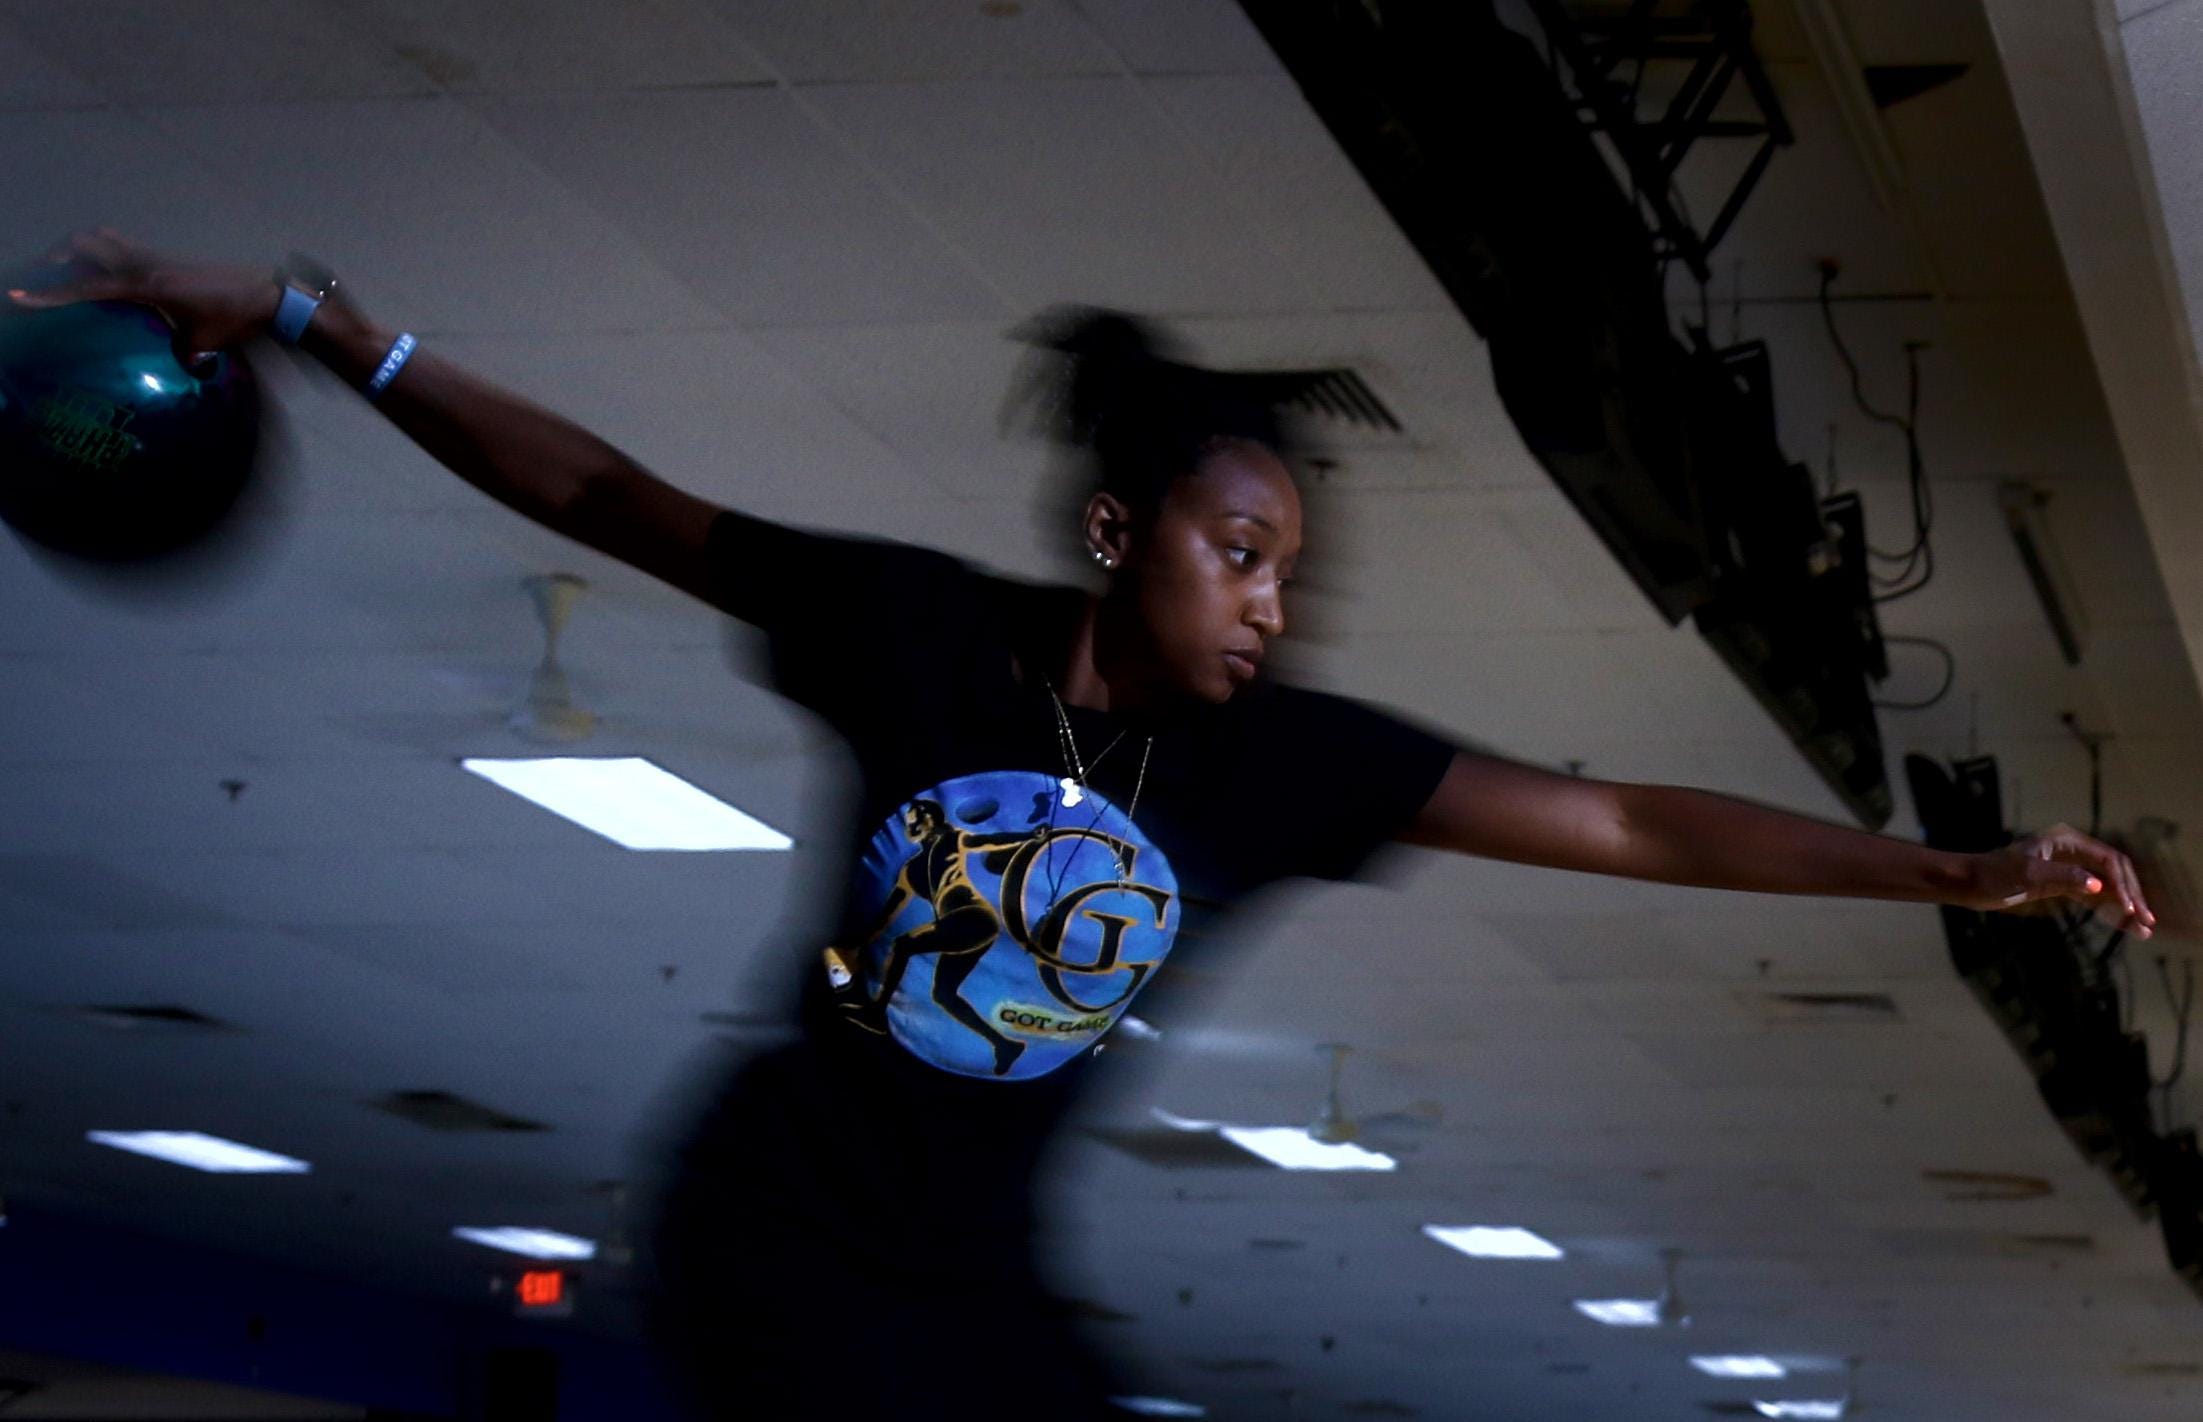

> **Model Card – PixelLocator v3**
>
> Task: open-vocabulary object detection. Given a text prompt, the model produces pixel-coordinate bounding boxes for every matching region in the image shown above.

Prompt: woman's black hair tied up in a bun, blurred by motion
[1013,306,1298,514]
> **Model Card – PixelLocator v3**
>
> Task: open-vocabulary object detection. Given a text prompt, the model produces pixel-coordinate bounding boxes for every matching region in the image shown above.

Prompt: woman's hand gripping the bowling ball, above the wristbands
[7,227,282,355]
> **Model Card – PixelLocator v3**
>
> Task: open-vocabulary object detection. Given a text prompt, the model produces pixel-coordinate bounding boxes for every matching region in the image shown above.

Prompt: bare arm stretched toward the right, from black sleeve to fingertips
[1401,752,2157,937]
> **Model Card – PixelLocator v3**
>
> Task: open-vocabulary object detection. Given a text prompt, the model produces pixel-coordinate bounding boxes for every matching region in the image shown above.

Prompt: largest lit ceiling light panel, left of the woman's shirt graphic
[460,756,795,849]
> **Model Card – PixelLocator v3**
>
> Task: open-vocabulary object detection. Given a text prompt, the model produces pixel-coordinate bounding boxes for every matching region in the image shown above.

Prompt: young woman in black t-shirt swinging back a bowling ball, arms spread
[11,231,2152,1418]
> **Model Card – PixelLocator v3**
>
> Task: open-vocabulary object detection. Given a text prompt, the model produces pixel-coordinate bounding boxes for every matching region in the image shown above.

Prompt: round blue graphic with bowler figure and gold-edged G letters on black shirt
[855,769,1179,1080]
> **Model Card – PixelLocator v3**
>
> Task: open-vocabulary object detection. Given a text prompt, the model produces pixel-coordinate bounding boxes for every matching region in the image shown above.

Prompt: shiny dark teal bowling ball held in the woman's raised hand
[0,265,260,564]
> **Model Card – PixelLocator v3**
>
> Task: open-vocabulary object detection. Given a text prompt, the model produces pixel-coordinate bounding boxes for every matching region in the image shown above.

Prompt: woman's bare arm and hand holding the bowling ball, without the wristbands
[11,229,723,597]
